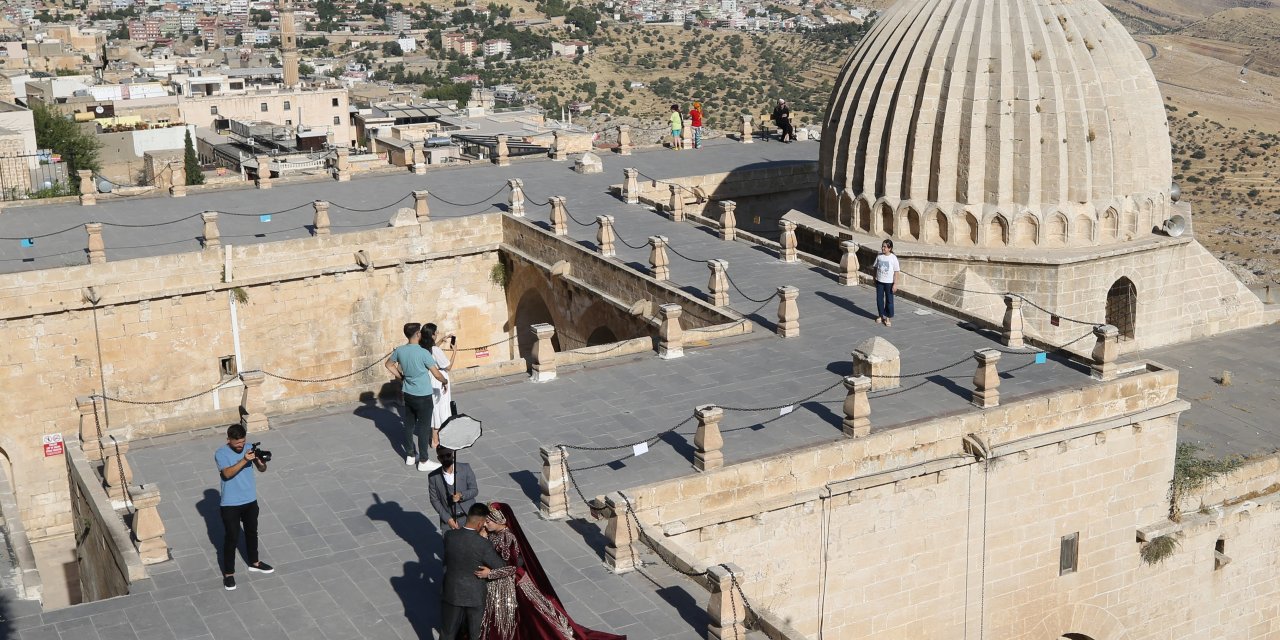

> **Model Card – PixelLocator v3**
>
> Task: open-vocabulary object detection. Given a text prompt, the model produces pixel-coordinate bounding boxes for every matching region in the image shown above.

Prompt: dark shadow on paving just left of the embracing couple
[365,493,444,640]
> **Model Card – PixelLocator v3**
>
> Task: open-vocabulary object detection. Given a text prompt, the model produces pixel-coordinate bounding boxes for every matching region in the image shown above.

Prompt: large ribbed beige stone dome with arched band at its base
[819,0,1172,247]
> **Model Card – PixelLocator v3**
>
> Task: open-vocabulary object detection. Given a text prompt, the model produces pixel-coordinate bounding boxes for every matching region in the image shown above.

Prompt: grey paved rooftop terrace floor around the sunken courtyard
[0,142,1276,640]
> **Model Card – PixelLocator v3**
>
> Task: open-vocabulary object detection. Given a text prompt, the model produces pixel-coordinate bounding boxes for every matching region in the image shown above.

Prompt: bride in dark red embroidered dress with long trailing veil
[480,502,626,640]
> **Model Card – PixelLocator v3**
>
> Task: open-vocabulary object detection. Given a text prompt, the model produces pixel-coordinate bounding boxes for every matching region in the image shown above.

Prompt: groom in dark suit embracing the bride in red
[440,504,507,640]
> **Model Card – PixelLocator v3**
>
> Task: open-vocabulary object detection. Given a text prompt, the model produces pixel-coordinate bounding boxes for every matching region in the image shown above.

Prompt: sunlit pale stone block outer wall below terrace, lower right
[627,364,1280,640]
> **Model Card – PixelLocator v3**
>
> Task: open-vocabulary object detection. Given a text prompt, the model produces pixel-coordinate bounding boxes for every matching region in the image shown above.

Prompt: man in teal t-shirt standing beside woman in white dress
[387,323,449,471]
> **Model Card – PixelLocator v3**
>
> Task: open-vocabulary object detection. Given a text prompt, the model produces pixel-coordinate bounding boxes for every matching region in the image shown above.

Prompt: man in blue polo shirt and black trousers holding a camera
[214,425,275,591]
